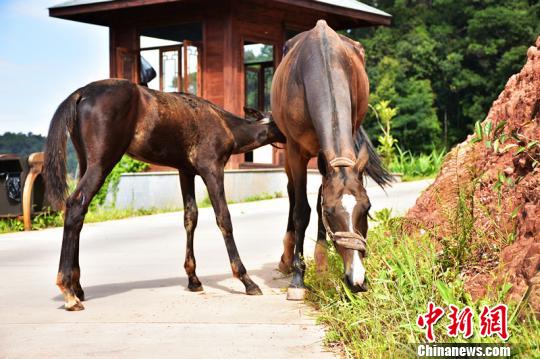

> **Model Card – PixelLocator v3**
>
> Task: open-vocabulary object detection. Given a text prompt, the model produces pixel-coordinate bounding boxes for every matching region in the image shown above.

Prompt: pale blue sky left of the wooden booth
[0,0,109,135]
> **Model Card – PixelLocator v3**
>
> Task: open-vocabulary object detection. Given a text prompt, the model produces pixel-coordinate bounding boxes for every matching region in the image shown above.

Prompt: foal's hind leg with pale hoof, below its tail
[56,164,114,311]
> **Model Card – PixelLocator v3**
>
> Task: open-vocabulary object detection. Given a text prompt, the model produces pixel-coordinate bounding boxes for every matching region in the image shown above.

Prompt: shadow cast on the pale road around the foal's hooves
[53,262,289,302]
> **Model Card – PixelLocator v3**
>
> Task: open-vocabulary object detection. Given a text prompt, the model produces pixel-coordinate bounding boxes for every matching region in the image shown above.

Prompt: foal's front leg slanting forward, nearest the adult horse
[201,166,262,295]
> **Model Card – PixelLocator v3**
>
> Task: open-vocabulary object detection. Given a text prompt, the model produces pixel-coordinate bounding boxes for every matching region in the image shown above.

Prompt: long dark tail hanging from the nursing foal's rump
[43,91,80,209]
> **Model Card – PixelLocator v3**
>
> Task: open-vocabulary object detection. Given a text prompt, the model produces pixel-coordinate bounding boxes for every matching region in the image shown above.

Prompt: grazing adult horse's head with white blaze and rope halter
[318,144,371,292]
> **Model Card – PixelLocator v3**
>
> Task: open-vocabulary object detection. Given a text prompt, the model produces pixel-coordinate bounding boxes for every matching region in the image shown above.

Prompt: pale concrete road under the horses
[0,181,428,359]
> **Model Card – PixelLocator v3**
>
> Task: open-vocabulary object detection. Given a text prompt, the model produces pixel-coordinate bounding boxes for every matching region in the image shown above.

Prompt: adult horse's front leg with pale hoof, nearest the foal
[287,145,311,300]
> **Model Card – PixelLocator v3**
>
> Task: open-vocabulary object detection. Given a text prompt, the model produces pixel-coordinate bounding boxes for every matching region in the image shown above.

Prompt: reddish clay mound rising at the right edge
[406,37,540,316]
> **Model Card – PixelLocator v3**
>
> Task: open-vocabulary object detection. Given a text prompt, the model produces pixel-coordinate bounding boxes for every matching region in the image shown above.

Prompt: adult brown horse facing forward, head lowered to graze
[272,20,390,300]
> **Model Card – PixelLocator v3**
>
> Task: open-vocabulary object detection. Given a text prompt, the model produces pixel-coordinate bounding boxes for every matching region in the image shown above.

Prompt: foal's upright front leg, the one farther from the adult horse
[180,172,203,292]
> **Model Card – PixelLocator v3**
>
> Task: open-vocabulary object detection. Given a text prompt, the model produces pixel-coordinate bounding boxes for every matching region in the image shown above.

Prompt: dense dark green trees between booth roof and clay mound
[345,0,540,153]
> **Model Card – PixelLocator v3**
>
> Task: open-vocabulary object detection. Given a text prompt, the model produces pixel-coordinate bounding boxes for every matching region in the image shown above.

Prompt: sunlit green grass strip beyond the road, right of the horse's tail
[388,146,446,181]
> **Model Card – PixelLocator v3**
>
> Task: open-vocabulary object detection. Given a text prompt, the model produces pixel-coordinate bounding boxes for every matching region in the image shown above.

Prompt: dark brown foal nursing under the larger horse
[44,80,284,310]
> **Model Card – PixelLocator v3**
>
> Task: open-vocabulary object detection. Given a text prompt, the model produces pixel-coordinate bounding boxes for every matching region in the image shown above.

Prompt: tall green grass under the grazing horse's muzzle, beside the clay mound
[306,215,540,358]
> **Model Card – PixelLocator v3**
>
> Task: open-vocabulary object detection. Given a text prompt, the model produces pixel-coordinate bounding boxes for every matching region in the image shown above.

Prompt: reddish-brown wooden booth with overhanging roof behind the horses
[49,0,391,168]
